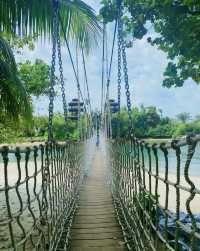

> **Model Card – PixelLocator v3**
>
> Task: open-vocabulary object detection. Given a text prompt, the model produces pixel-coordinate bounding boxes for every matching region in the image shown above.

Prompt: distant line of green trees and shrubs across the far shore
[0,105,200,143]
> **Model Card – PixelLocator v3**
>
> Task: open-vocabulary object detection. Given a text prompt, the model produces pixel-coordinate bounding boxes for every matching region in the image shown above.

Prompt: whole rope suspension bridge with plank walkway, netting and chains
[0,0,200,251]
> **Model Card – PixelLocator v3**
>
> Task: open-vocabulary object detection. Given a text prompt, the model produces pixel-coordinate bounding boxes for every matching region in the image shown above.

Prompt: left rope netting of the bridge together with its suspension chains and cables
[0,0,93,250]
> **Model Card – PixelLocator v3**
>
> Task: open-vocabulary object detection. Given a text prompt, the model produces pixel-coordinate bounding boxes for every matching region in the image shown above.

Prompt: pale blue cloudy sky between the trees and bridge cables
[18,0,200,117]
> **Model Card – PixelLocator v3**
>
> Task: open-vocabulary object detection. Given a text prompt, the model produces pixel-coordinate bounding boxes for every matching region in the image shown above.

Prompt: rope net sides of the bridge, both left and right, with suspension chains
[0,0,200,251]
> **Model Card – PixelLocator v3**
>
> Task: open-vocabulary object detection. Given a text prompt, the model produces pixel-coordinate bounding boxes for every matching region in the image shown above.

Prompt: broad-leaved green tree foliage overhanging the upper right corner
[102,0,200,88]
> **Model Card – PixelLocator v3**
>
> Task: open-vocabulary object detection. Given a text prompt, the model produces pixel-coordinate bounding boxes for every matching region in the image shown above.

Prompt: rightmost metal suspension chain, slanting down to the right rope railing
[118,1,132,133]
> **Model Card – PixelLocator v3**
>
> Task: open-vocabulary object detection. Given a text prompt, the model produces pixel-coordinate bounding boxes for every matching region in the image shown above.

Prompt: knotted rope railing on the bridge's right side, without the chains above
[109,136,200,251]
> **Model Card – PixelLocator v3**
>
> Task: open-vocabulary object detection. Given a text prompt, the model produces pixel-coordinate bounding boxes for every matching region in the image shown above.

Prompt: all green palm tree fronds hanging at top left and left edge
[0,0,100,118]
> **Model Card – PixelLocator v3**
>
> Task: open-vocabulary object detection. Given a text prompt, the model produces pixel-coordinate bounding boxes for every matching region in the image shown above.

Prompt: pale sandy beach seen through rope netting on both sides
[0,136,200,250]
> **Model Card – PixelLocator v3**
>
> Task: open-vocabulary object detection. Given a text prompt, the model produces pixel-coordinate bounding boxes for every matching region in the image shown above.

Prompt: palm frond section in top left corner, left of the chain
[0,0,52,36]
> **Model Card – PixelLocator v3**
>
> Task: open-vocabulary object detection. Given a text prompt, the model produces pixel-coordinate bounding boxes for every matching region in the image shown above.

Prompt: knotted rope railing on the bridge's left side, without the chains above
[0,142,84,250]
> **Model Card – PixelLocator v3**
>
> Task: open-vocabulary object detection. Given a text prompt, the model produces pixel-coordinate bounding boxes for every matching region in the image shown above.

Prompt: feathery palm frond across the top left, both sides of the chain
[0,0,101,49]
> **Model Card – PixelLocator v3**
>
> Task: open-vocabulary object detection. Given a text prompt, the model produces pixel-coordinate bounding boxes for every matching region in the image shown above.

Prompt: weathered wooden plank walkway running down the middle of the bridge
[71,150,125,251]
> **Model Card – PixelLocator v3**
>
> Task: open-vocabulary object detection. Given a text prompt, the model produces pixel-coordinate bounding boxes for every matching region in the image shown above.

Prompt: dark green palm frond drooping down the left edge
[0,37,32,122]
